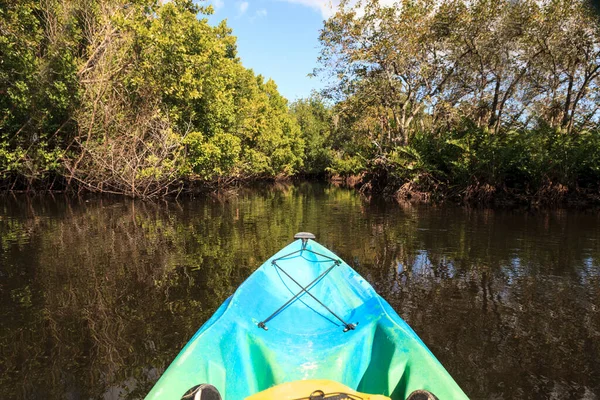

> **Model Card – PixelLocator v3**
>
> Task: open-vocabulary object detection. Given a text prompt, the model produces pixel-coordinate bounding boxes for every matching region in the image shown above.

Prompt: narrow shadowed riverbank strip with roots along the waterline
[0,171,600,209]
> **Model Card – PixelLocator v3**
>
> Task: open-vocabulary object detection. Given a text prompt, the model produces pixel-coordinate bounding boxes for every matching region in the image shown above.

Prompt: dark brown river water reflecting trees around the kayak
[0,184,600,399]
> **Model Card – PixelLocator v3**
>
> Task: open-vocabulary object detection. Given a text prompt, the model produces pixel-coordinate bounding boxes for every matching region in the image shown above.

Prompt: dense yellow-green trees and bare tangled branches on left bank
[0,0,303,197]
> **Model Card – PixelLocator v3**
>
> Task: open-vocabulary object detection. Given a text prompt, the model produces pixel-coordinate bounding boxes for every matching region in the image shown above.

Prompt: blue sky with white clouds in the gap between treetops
[201,0,331,101]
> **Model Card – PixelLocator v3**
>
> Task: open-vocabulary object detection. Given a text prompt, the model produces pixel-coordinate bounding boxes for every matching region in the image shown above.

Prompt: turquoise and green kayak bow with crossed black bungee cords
[146,233,467,400]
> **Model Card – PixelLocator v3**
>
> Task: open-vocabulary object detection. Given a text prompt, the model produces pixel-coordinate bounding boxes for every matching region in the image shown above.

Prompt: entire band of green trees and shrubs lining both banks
[0,0,600,201]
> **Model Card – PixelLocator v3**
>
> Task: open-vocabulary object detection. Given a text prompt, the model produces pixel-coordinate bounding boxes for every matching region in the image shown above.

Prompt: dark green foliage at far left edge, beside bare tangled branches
[0,1,81,181]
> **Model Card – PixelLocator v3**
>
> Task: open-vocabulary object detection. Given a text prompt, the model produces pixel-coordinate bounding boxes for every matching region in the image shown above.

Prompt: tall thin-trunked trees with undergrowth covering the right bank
[321,0,600,205]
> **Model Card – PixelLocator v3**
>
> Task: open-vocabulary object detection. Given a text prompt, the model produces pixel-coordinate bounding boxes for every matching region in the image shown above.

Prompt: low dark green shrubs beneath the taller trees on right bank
[376,129,600,195]
